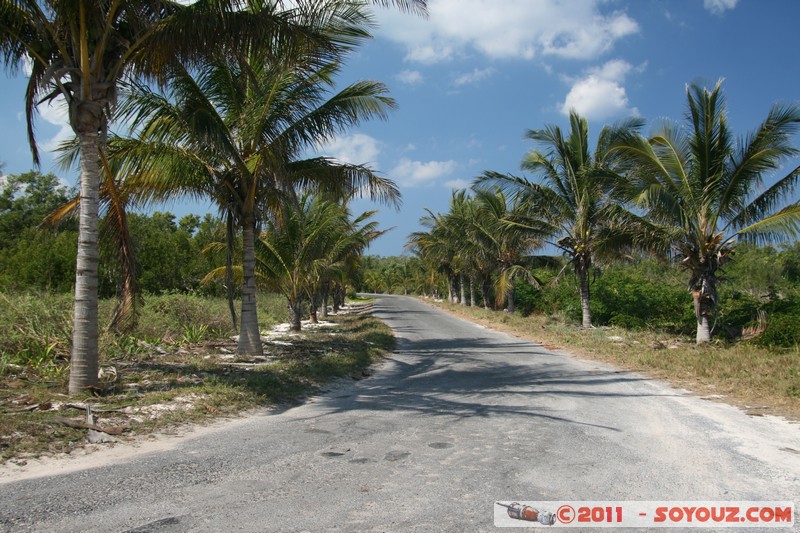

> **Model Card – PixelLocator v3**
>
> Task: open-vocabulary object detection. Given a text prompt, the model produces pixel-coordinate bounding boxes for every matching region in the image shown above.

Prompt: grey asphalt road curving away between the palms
[0,297,800,532]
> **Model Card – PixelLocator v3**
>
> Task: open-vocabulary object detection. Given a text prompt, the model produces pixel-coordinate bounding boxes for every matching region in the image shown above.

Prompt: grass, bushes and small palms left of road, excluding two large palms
[0,164,394,463]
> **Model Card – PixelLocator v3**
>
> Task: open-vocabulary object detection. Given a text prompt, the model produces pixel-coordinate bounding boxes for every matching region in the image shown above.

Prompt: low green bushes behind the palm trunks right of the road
[357,243,800,348]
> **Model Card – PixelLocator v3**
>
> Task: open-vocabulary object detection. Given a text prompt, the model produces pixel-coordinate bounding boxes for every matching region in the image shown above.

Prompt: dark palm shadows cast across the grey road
[290,337,676,432]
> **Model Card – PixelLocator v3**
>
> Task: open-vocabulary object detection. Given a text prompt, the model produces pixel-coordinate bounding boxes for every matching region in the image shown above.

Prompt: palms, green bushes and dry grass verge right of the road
[360,82,800,416]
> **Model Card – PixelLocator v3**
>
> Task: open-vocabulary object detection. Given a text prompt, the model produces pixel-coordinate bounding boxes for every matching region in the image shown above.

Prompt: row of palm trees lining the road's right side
[409,82,800,343]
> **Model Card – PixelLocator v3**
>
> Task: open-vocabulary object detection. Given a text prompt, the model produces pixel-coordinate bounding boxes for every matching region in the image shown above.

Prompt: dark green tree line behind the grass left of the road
[0,171,231,298]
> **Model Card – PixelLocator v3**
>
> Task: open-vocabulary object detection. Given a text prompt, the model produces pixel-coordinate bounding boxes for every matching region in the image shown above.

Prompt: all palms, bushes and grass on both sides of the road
[0,0,800,466]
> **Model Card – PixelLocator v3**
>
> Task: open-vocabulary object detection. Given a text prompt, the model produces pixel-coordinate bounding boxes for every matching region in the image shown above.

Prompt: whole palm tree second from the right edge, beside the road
[478,111,647,328]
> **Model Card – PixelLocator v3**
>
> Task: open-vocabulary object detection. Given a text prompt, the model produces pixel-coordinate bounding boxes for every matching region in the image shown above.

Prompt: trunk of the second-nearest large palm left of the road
[236,216,264,355]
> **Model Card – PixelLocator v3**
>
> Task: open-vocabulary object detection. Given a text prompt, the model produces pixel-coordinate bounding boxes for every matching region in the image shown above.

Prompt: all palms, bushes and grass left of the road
[0,0,427,460]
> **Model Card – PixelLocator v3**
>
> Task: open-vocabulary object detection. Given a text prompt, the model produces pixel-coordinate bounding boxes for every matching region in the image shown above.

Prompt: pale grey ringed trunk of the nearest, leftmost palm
[69,130,100,394]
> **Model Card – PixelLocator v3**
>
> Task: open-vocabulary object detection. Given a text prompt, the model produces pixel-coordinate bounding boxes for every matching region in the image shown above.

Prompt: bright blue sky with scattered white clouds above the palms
[0,0,800,255]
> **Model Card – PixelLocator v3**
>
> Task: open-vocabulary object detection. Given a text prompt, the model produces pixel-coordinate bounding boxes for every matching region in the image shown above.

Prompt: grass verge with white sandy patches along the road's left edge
[0,315,394,464]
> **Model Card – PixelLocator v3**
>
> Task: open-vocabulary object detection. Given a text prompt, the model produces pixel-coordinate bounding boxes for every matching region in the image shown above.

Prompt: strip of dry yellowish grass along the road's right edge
[431,302,800,420]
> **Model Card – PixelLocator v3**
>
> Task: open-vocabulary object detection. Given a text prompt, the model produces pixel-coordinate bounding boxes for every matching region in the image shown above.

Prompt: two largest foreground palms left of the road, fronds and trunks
[0,0,426,394]
